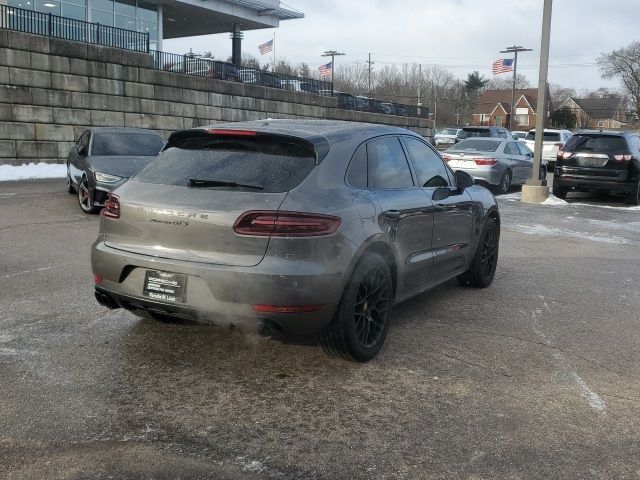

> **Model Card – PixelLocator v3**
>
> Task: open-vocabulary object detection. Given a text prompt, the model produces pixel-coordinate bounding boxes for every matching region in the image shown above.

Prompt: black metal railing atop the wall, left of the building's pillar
[0,5,149,53]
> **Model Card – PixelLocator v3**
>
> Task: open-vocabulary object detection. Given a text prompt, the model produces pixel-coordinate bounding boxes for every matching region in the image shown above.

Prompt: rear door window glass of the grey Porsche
[367,137,413,188]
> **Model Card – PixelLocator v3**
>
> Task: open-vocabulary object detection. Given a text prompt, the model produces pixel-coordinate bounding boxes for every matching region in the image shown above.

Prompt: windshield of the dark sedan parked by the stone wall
[91,133,164,157]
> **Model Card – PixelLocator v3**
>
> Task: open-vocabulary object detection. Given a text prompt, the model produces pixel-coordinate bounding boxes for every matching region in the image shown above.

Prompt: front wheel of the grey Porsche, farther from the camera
[457,218,500,288]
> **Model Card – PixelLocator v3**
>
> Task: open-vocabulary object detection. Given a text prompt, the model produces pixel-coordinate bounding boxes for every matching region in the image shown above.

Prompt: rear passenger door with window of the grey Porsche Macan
[367,136,433,294]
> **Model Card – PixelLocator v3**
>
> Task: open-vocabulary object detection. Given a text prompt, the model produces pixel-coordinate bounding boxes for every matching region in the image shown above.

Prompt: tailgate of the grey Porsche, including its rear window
[104,130,316,266]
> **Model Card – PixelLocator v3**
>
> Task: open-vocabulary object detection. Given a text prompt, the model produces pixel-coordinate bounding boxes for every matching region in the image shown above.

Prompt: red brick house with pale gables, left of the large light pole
[471,88,549,130]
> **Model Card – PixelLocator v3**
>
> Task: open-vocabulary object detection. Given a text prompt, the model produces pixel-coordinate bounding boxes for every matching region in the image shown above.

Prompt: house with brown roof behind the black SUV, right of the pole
[558,97,627,130]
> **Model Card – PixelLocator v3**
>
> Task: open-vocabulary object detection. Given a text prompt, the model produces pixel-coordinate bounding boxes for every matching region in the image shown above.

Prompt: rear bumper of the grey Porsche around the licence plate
[91,239,348,334]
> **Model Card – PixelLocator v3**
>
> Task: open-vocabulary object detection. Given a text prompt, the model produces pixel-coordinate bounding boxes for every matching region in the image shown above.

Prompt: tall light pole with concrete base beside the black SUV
[522,0,553,203]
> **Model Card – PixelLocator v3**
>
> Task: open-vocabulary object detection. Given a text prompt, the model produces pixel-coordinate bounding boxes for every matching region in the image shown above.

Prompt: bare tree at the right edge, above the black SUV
[598,41,640,117]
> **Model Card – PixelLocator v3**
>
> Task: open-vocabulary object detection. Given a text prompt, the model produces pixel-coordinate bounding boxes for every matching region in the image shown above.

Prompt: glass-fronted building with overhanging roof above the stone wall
[0,0,304,50]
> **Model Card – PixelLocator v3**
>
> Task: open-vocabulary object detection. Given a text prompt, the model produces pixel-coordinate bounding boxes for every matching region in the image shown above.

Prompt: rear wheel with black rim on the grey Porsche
[318,253,393,362]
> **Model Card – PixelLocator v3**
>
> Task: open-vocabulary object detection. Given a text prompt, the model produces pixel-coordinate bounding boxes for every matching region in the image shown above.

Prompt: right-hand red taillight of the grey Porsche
[233,211,341,237]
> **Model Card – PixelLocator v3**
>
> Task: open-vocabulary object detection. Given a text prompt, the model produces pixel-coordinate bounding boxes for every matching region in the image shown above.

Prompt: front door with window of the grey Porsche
[402,136,473,281]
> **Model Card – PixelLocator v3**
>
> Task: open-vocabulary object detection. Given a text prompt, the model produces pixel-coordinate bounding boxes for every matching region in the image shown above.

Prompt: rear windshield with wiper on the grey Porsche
[135,135,316,193]
